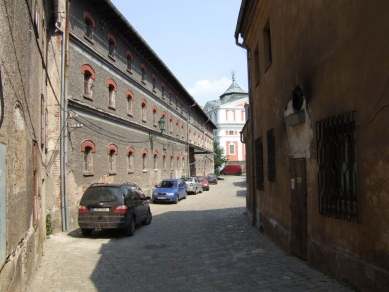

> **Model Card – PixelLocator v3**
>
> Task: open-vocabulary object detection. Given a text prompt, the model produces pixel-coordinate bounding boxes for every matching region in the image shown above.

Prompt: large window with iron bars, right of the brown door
[316,112,359,221]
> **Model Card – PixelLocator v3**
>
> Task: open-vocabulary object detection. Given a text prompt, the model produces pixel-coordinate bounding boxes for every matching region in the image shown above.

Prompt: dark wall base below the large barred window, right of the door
[308,242,389,292]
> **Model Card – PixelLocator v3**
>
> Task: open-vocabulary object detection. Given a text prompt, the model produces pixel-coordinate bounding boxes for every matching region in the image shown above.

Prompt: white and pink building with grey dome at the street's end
[203,71,248,164]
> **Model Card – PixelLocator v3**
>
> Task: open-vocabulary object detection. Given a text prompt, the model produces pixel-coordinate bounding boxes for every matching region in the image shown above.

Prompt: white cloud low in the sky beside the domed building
[188,77,232,106]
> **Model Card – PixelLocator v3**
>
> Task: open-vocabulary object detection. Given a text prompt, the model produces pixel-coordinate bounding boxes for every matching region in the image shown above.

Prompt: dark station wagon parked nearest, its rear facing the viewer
[78,183,152,236]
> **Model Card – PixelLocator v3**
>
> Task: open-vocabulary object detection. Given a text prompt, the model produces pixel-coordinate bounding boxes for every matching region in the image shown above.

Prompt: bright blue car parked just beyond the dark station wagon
[153,179,188,204]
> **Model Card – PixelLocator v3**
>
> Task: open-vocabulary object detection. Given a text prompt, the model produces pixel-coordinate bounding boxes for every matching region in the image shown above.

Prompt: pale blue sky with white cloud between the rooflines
[111,0,247,106]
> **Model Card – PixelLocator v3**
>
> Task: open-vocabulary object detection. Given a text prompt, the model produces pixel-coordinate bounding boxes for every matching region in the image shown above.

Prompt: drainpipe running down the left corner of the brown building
[235,32,256,226]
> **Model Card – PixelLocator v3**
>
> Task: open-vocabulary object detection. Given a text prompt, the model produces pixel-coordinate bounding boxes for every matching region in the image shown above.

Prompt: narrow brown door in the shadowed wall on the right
[289,158,308,260]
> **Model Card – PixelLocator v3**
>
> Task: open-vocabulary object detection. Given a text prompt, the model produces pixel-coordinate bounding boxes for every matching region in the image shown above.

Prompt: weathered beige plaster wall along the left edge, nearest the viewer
[0,0,55,291]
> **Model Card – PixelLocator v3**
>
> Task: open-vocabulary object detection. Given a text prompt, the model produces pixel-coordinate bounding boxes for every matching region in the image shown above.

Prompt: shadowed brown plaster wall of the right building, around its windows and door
[238,0,389,291]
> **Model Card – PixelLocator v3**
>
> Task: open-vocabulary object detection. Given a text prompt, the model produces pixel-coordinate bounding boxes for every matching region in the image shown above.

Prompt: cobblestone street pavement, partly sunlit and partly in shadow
[27,176,350,292]
